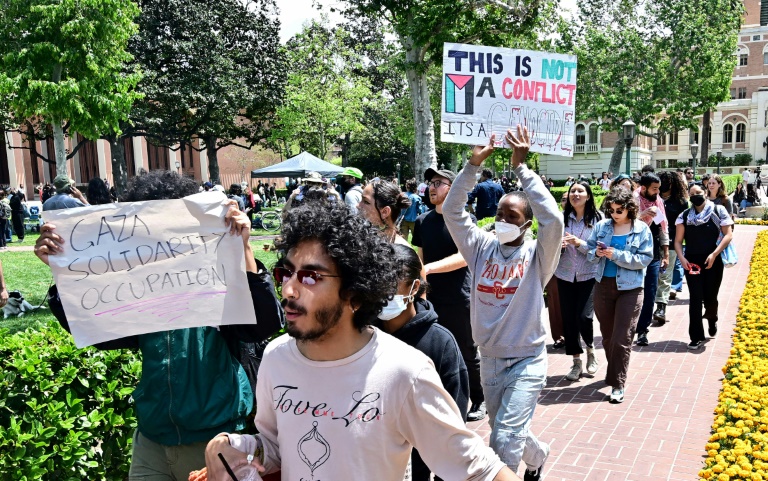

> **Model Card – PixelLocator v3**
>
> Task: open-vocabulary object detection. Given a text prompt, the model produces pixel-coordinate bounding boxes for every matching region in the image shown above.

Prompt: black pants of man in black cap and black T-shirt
[430,299,485,404]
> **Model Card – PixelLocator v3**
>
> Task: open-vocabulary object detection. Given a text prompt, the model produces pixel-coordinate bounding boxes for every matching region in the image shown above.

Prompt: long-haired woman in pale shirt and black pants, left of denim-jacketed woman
[555,181,603,381]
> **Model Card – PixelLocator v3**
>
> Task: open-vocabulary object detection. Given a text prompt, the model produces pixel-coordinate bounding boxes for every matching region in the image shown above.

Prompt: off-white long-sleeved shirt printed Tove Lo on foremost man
[230,329,504,481]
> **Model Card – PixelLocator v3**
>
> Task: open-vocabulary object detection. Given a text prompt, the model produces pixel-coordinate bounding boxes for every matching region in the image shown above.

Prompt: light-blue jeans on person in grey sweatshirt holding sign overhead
[480,349,549,471]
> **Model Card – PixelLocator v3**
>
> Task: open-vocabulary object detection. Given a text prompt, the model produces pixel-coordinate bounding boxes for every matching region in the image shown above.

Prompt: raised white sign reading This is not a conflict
[440,43,576,157]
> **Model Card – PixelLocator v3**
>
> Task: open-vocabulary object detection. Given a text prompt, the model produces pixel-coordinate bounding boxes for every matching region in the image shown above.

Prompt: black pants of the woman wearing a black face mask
[685,254,724,341]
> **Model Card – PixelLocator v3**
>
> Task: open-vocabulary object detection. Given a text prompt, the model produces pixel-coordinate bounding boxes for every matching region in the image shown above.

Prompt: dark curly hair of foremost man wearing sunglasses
[275,199,399,330]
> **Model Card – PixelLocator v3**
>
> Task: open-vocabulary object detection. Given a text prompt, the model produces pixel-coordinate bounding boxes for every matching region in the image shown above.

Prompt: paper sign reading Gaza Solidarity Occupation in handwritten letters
[45,192,256,347]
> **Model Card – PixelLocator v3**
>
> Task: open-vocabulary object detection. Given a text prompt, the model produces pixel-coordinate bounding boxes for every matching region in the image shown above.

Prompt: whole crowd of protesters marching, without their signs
[22,128,757,481]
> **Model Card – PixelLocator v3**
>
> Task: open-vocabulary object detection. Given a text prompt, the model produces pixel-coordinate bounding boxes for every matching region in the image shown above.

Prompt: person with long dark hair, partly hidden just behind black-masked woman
[653,171,688,324]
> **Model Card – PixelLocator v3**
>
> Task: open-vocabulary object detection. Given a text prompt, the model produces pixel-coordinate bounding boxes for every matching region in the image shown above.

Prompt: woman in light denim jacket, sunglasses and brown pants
[587,188,653,403]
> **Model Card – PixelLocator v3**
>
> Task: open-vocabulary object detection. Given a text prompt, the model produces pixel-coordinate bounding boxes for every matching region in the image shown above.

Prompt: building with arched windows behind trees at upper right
[540,0,768,179]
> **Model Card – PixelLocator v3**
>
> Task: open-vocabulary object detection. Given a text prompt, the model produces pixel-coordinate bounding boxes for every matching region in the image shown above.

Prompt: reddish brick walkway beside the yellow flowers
[470,225,764,481]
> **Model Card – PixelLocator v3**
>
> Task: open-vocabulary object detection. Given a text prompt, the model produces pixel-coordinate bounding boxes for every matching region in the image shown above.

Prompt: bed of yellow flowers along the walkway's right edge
[699,231,768,481]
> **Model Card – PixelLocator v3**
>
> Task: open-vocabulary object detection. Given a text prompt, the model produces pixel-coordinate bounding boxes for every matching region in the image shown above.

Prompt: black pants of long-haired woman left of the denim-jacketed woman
[557,279,595,356]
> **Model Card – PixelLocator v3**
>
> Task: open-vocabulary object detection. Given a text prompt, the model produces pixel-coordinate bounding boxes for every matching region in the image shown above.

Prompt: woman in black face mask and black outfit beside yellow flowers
[675,184,733,350]
